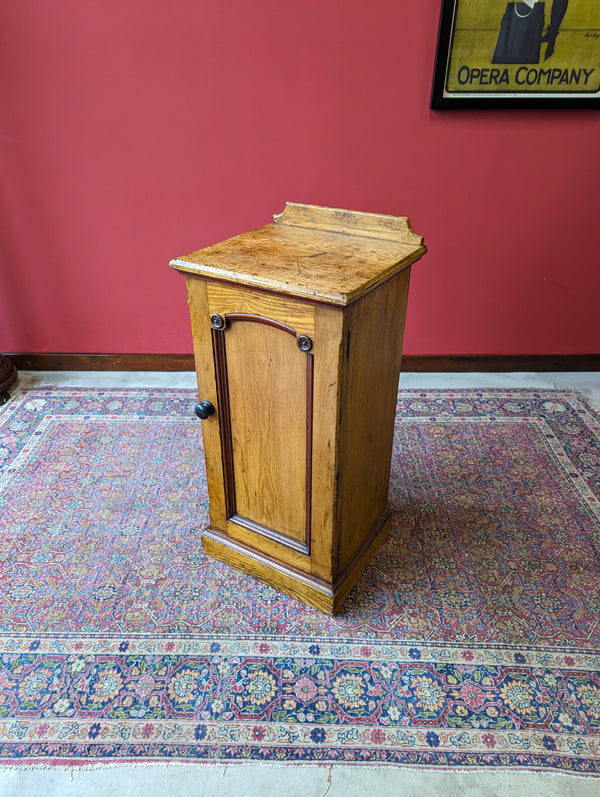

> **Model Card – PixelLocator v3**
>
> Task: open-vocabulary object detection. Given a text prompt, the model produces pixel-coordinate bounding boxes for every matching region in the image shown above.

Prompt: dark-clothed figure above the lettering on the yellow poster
[492,0,569,64]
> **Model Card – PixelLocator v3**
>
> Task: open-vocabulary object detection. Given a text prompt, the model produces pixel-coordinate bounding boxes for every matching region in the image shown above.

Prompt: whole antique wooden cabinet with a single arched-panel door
[171,203,426,614]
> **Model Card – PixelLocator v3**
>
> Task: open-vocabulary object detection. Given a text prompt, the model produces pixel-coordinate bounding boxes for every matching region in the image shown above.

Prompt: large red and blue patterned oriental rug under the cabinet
[0,388,600,775]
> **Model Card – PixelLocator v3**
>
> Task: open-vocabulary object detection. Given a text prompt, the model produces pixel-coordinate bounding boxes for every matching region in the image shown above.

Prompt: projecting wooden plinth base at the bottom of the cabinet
[202,512,391,615]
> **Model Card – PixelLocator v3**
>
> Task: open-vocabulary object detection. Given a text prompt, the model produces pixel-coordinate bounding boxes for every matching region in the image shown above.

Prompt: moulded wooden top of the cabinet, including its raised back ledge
[171,203,426,305]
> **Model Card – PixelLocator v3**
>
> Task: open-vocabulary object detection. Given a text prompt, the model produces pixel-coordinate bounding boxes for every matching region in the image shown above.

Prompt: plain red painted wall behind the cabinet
[0,0,600,354]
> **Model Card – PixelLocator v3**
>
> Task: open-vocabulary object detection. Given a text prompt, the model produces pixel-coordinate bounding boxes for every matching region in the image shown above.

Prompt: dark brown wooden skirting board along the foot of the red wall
[8,354,600,373]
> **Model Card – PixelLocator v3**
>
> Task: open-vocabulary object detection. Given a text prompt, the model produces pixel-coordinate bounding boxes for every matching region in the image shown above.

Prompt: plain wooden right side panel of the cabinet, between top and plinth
[338,269,410,574]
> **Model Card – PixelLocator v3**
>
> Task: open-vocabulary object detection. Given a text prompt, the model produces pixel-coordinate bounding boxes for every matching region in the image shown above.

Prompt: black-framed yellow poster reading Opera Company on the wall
[431,0,600,109]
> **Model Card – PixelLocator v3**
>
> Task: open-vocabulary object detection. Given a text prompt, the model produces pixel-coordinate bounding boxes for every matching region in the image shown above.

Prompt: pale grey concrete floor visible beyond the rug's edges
[0,371,600,797]
